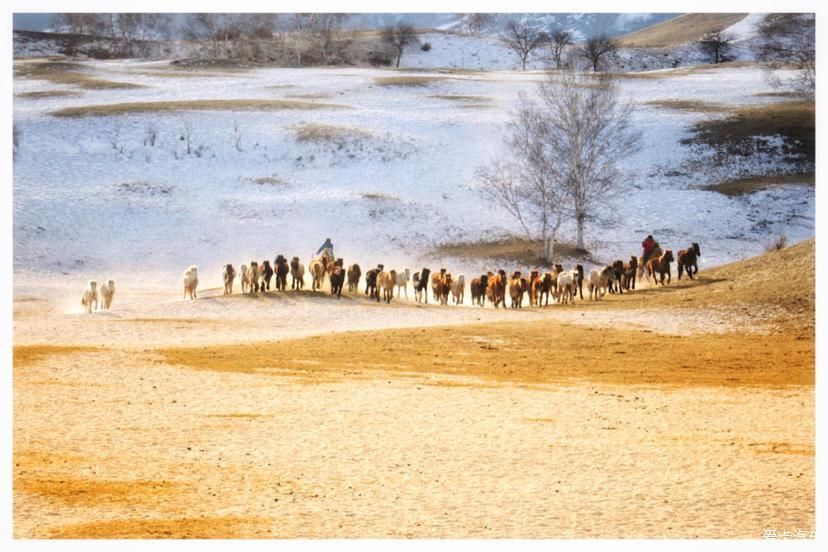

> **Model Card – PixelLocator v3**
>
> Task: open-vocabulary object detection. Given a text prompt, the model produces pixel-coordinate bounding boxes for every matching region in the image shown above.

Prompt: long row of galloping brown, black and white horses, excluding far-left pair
[205,242,701,308]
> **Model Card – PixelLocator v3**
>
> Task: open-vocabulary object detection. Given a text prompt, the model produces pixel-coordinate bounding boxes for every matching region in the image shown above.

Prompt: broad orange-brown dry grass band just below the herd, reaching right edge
[158,322,814,388]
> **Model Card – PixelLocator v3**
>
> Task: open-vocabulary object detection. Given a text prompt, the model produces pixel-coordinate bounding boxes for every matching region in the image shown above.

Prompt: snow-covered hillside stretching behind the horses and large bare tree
[14,58,814,294]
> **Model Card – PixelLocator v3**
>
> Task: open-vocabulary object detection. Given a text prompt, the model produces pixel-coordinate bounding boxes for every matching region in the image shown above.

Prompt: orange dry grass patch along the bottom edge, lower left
[51,516,278,539]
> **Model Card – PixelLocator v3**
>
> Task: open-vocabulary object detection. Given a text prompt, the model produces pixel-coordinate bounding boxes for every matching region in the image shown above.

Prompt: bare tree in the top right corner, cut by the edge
[756,13,816,98]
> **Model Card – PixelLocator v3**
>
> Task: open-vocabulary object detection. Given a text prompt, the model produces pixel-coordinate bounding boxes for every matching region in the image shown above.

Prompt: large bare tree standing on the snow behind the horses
[478,71,640,261]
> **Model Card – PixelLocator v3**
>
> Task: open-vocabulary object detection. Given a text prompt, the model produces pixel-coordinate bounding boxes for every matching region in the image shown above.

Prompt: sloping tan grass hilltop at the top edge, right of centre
[619,13,747,48]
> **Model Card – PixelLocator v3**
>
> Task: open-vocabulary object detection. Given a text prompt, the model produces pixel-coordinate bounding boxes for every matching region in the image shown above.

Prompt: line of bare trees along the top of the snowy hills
[55,13,816,96]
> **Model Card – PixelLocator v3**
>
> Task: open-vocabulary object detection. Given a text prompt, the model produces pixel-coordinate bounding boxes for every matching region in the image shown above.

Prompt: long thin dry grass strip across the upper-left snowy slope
[50,99,345,117]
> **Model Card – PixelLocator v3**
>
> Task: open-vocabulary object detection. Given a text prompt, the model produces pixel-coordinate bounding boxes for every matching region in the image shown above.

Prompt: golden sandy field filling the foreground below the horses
[13,240,815,539]
